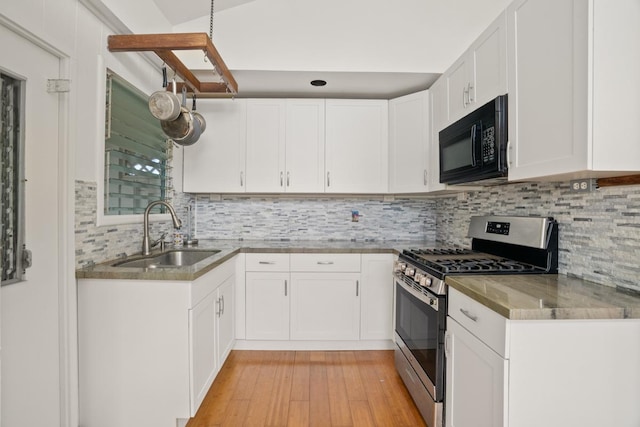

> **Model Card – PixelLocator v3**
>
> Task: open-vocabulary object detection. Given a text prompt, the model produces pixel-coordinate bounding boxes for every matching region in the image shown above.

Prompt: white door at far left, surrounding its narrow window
[0,25,65,427]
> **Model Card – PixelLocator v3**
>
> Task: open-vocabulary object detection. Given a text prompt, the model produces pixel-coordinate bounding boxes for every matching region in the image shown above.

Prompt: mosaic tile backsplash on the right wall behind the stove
[436,183,640,291]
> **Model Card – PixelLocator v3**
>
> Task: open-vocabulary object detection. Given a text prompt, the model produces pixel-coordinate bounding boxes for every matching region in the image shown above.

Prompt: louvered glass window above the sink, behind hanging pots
[104,71,173,215]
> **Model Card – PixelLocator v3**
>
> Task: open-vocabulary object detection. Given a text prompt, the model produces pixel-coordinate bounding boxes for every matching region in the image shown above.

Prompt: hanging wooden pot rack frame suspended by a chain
[107,33,238,95]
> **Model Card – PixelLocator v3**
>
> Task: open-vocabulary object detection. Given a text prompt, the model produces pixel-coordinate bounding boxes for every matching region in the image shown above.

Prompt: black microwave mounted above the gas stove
[439,95,508,184]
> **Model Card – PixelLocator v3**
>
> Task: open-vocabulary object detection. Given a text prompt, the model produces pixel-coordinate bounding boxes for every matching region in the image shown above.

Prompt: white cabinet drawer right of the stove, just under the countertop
[447,287,508,358]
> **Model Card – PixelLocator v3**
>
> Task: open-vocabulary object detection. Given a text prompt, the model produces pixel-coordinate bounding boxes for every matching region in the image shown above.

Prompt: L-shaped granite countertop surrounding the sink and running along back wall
[76,240,424,281]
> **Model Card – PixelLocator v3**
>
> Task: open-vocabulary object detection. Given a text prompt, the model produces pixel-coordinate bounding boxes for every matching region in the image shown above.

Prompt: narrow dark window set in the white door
[0,73,24,285]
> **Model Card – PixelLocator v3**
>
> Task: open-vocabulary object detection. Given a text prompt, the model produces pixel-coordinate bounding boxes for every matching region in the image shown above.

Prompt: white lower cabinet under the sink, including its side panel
[78,258,236,427]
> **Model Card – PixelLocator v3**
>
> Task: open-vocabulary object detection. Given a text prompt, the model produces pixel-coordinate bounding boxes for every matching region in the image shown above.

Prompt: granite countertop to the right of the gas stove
[446,274,640,320]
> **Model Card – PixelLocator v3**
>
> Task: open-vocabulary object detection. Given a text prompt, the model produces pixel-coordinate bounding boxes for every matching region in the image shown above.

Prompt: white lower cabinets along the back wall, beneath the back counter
[240,253,394,348]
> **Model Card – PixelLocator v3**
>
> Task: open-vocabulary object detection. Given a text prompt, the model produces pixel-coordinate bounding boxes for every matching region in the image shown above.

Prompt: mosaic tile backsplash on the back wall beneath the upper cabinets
[195,195,436,241]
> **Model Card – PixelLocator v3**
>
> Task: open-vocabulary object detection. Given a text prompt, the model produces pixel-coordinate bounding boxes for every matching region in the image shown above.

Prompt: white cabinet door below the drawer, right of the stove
[445,317,508,427]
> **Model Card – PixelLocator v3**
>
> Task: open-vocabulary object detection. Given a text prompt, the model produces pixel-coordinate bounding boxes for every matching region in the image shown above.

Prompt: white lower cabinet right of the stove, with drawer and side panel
[445,287,640,427]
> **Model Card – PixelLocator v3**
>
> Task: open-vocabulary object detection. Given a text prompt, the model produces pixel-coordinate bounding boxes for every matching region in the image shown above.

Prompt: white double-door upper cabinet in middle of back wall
[247,99,324,193]
